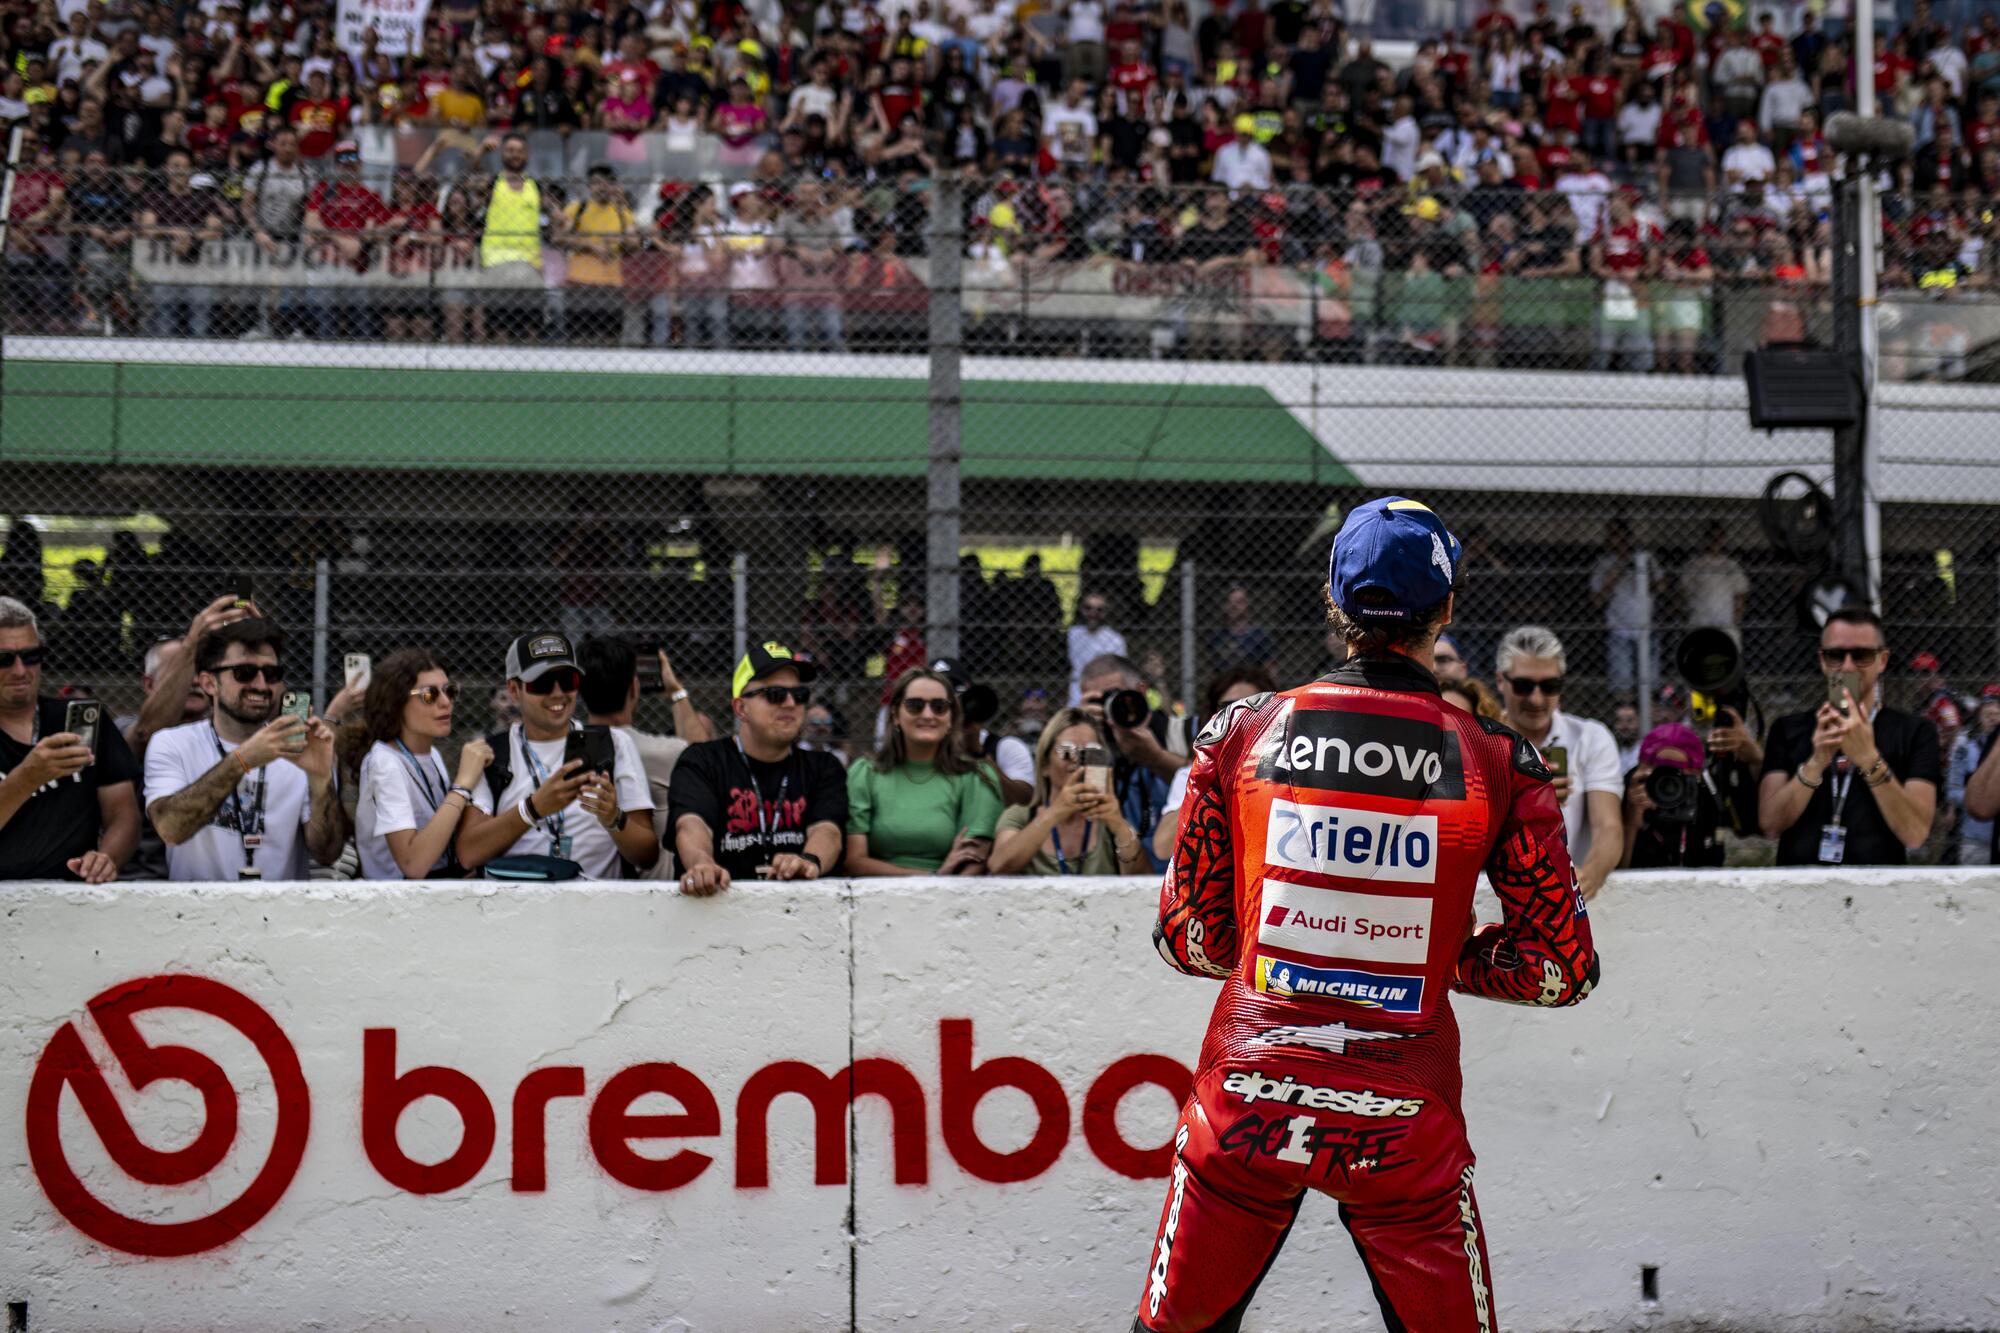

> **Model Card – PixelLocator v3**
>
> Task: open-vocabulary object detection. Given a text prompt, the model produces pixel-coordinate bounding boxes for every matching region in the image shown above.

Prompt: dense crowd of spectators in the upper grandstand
[11,0,2000,358]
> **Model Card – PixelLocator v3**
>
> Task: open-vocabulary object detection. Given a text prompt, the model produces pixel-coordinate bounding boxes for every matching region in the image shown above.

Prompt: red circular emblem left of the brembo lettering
[28,977,312,1257]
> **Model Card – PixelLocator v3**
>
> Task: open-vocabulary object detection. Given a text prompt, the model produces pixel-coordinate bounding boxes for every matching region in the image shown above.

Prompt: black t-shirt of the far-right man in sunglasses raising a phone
[1764,709,1942,865]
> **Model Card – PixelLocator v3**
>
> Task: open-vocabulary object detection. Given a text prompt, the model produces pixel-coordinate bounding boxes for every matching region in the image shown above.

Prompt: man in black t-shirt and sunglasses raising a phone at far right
[1758,606,1944,865]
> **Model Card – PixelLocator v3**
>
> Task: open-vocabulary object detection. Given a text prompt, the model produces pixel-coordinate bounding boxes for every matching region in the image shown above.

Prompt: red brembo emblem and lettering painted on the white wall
[26,975,1192,1259]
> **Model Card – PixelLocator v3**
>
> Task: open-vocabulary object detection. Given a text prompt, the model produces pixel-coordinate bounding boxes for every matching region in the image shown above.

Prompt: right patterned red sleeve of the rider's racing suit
[1452,739,1598,1005]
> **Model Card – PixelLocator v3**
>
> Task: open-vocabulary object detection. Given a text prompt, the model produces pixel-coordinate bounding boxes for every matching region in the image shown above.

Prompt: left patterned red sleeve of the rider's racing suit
[1152,695,1270,977]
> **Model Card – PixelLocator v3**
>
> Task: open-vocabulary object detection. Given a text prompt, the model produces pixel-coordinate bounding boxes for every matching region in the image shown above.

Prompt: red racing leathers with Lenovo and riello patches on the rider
[1138,656,1598,1333]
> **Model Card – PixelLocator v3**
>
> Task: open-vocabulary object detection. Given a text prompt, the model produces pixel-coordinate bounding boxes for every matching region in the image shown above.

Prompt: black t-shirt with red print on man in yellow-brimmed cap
[666,739,848,881]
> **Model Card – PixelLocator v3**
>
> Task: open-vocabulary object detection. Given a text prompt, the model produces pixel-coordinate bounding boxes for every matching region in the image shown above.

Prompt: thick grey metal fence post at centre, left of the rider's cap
[924,172,964,658]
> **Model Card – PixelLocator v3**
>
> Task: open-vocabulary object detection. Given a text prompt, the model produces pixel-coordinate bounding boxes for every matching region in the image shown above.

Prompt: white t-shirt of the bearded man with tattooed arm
[146,723,312,881]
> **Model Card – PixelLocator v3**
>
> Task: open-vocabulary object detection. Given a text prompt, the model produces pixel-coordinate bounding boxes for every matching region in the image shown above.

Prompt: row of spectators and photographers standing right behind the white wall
[0,536,2000,897]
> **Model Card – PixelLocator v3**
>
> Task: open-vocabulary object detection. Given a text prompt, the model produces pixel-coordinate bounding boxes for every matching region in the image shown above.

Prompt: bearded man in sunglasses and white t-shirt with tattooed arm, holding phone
[146,618,348,881]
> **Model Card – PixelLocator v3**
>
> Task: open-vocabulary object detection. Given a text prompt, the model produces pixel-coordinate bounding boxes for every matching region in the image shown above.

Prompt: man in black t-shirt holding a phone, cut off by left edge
[0,596,138,885]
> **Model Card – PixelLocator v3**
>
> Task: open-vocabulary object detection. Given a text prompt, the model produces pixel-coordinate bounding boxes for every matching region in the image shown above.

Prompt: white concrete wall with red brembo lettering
[0,871,2000,1333]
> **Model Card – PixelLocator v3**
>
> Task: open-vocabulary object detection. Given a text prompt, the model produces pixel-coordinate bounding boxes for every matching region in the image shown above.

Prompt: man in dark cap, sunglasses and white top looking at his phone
[458,630,660,879]
